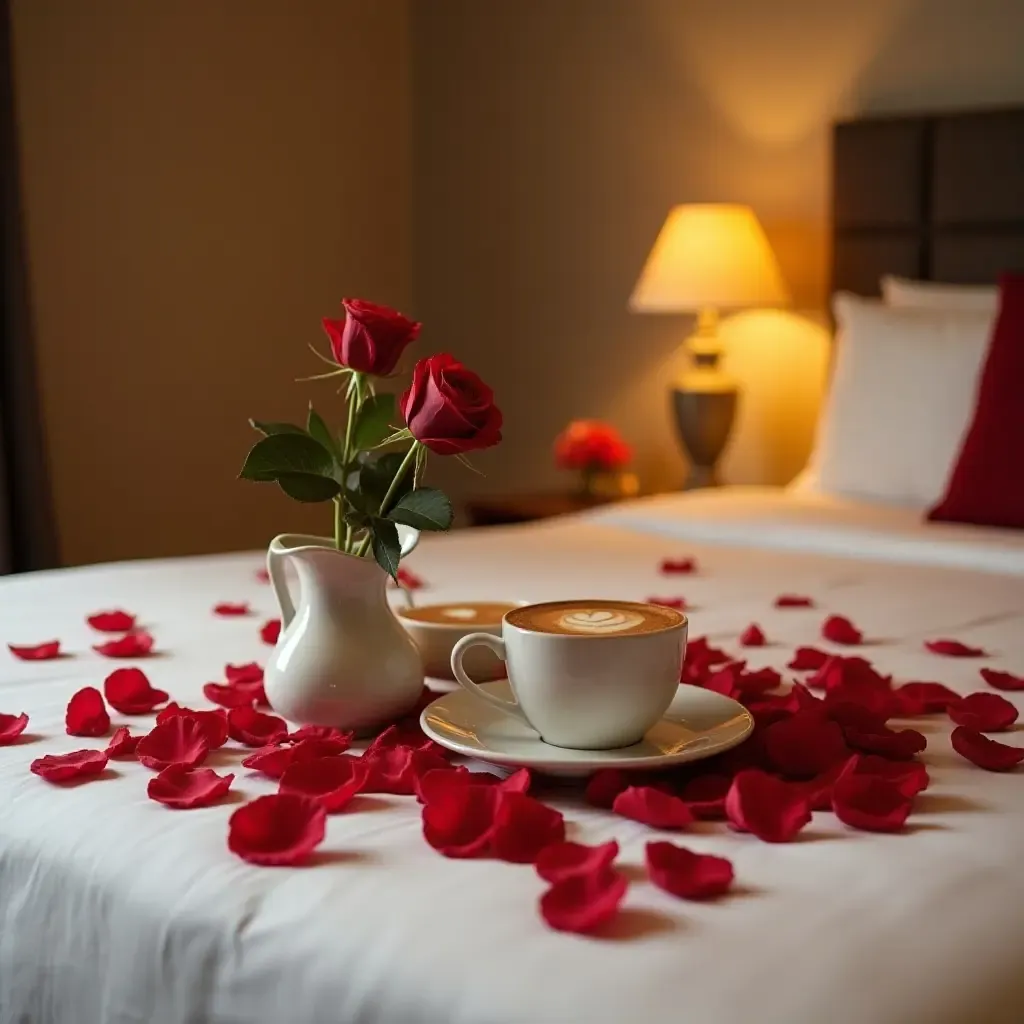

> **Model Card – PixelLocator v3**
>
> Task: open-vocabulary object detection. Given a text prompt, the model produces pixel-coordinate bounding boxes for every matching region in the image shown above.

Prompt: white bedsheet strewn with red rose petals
[0,496,1024,1024]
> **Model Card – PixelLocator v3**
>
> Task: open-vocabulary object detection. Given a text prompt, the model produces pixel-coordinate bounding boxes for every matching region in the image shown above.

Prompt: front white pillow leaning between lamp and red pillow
[794,293,992,509]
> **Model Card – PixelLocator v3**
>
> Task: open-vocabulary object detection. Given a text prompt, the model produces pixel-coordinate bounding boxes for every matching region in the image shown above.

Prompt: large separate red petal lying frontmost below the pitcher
[227,793,327,867]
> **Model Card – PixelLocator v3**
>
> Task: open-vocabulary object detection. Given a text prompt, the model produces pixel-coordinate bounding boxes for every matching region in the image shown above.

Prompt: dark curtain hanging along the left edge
[0,0,57,573]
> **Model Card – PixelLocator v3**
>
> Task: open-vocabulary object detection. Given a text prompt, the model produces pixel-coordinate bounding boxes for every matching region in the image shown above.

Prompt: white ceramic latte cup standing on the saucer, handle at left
[452,600,687,750]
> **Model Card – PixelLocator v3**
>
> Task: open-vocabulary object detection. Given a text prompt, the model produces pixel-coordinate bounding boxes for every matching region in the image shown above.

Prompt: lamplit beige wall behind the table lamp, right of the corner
[414,0,1024,505]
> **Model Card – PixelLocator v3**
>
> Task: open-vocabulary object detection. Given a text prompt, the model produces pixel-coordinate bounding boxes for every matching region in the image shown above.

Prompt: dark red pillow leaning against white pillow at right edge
[928,273,1024,529]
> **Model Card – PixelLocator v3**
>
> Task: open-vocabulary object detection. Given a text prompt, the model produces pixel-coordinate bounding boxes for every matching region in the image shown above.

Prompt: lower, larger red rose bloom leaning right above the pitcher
[401,352,502,455]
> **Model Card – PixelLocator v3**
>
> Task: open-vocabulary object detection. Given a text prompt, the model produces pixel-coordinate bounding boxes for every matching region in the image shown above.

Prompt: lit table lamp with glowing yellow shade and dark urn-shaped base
[630,203,788,489]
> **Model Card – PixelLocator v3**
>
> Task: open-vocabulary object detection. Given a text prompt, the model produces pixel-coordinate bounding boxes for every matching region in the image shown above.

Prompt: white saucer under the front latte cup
[420,679,754,776]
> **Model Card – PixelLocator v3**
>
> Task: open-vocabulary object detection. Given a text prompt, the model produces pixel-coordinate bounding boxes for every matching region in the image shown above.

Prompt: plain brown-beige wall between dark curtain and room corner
[13,0,410,563]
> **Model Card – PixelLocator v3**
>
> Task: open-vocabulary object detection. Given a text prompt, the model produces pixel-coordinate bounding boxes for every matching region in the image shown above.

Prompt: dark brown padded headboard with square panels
[831,108,1024,295]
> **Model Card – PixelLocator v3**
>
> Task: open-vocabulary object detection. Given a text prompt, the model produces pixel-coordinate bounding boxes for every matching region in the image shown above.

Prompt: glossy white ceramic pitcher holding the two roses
[264,526,423,731]
